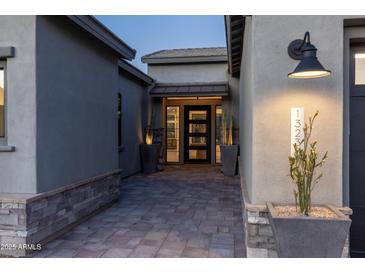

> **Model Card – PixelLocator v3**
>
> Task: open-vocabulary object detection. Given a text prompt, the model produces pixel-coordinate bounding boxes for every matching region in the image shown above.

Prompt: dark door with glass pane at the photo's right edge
[350,46,365,257]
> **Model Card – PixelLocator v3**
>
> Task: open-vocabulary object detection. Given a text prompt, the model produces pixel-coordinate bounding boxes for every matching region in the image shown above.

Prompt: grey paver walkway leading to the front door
[34,166,245,258]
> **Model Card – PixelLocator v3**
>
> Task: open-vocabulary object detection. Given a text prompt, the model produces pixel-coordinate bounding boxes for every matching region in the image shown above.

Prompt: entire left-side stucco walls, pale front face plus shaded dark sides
[0,16,150,193]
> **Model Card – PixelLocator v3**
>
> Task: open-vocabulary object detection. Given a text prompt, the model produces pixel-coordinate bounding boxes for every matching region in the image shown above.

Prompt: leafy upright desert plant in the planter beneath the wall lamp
[289,111,328,216]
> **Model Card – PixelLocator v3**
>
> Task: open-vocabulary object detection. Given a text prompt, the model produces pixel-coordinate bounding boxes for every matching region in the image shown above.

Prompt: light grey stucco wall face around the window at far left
[0,16,36,193]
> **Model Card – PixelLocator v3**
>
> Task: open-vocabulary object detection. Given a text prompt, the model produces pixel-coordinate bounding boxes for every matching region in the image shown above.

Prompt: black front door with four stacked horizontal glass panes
[184,106,211,164]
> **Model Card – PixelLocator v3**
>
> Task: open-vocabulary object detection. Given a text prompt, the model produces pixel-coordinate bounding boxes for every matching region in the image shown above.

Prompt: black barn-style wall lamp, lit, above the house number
[288,31,331,79]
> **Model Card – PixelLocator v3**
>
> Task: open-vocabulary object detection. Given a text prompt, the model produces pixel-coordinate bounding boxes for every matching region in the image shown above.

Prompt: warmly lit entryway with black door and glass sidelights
[164,96,223,165]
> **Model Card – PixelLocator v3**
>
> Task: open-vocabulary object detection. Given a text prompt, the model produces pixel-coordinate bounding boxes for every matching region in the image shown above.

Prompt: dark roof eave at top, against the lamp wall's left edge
[224,15,245,78]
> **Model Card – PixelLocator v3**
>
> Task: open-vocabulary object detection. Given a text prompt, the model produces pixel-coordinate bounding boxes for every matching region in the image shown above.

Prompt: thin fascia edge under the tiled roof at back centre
[141,55,227,64]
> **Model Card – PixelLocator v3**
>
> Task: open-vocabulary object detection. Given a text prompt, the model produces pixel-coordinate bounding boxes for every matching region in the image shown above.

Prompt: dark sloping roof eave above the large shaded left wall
[67,15,136,60]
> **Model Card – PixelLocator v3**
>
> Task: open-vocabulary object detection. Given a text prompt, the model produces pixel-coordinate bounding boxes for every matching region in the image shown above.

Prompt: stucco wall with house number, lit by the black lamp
[241,16,343,206]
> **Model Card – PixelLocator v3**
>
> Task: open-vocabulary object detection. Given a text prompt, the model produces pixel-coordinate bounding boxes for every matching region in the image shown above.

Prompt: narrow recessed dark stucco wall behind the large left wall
[118,71,148,177]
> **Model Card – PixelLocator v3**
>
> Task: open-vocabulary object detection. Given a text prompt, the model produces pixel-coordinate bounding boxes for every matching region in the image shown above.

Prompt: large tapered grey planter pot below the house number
[267,203,351,258]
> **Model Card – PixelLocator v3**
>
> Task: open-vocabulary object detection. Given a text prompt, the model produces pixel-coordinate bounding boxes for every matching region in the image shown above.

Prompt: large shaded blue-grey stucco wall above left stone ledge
[37,16,120,192]
